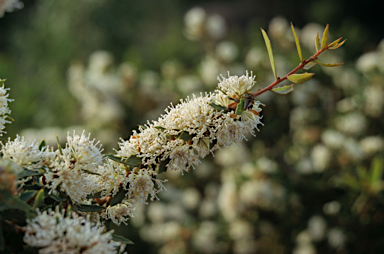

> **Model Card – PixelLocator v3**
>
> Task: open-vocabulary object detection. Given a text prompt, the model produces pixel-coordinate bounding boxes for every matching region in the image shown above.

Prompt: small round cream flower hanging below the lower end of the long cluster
[127,168,165,203]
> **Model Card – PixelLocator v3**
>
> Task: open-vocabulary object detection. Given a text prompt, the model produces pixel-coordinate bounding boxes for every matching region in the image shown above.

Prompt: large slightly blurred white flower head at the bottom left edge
[24,210,120,254]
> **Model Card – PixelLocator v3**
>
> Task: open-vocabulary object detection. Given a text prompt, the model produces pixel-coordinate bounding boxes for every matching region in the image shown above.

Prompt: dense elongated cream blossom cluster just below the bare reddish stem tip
[117,70,261,172]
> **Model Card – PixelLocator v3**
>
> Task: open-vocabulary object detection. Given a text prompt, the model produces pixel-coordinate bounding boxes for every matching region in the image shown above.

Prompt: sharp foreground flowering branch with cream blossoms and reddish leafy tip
[0,18,344,253]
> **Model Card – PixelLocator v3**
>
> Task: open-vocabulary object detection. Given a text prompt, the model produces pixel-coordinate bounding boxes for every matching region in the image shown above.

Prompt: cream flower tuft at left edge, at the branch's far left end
[1,135,49,170]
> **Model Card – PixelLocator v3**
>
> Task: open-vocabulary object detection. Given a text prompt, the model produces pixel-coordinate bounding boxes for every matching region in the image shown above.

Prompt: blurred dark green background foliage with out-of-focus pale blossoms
[0,0,384,254]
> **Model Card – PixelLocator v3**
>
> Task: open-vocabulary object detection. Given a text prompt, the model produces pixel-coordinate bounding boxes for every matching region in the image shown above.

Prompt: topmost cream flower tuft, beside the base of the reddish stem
[217,71,256,97]
